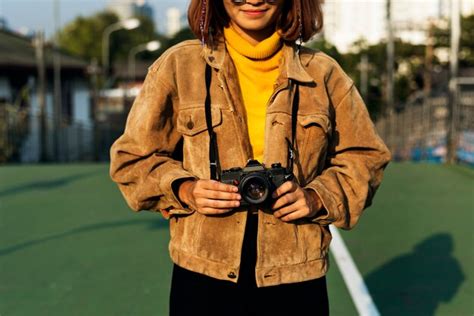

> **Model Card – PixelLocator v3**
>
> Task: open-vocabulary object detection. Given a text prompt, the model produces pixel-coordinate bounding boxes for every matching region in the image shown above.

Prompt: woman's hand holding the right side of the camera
[272,181,323,222]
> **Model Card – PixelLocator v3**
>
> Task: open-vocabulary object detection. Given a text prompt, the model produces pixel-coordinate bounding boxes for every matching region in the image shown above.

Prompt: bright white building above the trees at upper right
[324,0,474,53]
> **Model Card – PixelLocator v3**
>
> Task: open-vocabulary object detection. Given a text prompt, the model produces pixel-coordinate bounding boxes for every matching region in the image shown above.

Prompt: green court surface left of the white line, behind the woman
[0,164,355,316]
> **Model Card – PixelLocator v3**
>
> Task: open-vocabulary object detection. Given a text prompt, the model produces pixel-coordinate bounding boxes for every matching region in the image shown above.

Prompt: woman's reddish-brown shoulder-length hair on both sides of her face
[188,0,323,42]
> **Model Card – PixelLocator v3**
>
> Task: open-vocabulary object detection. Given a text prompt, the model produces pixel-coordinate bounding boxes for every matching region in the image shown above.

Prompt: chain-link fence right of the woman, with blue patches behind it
[376,87,474,164]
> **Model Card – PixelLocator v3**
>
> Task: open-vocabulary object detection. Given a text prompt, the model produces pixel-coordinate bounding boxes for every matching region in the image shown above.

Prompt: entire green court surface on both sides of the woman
[0,164,474,316]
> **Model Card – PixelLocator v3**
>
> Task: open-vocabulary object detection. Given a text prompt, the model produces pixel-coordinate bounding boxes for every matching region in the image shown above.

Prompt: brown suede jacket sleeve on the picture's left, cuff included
[110,67,194,218]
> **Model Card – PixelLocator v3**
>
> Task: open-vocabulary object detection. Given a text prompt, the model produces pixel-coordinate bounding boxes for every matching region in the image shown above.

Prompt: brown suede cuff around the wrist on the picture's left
[160,169,197,218]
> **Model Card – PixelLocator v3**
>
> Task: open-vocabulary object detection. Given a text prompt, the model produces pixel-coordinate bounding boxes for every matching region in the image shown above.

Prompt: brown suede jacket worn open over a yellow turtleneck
[110,40,390,287]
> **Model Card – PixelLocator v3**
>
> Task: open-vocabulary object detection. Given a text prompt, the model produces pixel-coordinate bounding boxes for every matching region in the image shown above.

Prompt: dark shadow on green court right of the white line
[365,233,465,316]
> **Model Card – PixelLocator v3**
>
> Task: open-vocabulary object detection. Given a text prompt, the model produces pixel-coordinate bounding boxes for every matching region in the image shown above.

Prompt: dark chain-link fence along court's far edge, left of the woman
[0,104,123,163]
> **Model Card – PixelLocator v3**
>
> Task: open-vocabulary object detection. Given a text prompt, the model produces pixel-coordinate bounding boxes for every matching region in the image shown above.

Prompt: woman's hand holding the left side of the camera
[178,180,241,215]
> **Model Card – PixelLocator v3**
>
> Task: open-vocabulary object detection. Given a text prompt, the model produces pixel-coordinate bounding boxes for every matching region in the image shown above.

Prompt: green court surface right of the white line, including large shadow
[342,163,474,316]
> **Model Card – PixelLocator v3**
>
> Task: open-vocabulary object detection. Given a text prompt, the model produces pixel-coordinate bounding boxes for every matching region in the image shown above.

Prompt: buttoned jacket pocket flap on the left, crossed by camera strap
[176,107,222,136]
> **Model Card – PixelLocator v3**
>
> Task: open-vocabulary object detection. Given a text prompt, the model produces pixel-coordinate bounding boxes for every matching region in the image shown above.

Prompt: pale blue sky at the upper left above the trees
[0,0,193,37]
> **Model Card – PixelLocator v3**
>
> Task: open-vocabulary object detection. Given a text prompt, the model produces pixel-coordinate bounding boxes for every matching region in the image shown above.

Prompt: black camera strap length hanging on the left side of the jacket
[204,64,220,180]
